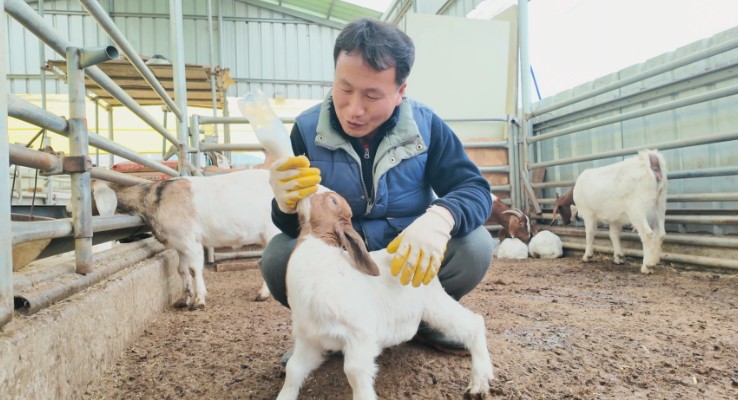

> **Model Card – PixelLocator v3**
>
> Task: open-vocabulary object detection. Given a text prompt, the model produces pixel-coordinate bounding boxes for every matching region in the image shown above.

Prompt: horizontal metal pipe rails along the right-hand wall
[523,32,738,269]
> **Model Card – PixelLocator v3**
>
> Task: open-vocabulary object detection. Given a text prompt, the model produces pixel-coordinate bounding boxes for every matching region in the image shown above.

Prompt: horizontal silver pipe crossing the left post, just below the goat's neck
[10,215,144,245]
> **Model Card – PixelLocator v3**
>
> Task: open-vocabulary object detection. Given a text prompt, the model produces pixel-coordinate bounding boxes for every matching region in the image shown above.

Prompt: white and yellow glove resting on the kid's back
[387,206,454,287]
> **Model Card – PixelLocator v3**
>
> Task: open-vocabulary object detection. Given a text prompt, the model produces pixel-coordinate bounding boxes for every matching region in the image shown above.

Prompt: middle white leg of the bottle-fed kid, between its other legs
[343,340,382,400]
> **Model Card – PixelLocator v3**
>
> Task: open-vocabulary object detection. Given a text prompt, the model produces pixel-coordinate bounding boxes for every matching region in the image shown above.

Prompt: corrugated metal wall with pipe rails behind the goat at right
[522,25,738,268]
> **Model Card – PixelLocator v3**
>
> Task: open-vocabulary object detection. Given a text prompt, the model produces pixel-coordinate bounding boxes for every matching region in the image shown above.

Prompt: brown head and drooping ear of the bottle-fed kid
[297,186,379,276]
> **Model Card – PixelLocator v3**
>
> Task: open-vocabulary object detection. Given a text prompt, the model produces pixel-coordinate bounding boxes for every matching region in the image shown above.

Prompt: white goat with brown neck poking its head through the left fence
[95,169,279,309]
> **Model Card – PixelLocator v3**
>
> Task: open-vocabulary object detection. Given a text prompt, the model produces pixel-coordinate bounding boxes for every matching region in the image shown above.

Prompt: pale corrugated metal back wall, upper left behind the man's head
[7,0,339,99]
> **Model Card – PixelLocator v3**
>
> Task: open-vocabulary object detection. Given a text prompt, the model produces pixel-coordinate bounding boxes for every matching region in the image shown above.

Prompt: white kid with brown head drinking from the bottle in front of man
[278,188,493,400]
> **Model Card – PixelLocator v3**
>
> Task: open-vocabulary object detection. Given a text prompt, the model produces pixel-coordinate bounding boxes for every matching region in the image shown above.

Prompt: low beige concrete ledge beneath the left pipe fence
[0,245,181,399]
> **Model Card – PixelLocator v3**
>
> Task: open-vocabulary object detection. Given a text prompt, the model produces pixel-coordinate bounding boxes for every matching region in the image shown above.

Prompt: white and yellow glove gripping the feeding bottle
[269,156,320,214]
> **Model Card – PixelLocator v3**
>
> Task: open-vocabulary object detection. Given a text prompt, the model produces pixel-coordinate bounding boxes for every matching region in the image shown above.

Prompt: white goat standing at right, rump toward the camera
[554,150,667,274]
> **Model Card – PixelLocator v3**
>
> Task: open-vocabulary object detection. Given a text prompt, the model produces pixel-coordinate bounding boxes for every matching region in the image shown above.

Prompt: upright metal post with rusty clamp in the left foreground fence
[66,47,93,275]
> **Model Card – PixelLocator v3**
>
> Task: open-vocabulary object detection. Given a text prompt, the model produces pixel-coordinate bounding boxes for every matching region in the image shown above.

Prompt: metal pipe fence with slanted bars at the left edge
[0,0,196,326]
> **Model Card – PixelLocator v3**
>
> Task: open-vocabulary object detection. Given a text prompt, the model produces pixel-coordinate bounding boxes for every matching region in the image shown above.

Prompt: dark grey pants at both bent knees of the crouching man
[259,226,495,307]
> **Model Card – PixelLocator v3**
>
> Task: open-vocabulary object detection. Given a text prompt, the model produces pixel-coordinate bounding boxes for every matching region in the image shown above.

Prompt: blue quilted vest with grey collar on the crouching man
[295,95,436,251]
